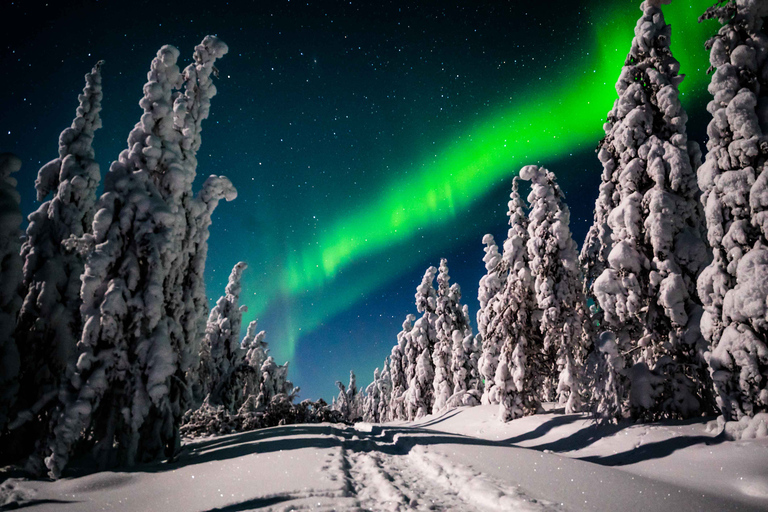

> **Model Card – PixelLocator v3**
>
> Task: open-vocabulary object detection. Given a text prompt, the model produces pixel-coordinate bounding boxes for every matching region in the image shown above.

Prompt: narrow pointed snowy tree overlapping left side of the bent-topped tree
[486,177,544,421]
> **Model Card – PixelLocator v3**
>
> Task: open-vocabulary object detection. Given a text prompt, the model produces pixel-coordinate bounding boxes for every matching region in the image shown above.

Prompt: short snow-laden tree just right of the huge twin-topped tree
[200,261,248,412]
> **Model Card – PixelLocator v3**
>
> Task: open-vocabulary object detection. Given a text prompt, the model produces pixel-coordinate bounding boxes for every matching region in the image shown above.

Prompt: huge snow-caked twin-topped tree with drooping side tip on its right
[46,36,230,477]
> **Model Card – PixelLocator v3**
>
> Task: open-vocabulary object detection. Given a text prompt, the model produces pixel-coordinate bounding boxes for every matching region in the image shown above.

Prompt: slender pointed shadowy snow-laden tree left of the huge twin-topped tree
[11,62,102,449]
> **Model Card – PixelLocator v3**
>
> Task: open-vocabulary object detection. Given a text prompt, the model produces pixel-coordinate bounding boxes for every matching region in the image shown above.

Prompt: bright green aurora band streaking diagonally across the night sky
[244,0,716,360]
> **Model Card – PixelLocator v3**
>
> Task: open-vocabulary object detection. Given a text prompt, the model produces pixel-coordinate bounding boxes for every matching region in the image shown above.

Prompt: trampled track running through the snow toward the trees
[258,427,559,512]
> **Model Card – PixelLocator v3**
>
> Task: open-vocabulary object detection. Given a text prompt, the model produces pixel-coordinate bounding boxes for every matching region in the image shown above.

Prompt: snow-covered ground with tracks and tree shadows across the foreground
[0,406,768,512]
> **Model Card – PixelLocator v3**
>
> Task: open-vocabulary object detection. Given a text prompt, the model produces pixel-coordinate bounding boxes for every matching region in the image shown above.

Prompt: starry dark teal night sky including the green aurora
[0,0,716,401]
